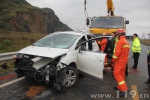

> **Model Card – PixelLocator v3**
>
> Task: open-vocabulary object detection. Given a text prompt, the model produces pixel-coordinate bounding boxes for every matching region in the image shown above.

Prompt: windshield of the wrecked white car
[32,33,79,49]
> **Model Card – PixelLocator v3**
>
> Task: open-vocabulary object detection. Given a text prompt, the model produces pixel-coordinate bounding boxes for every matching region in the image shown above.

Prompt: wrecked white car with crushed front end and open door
[14,31,105,90]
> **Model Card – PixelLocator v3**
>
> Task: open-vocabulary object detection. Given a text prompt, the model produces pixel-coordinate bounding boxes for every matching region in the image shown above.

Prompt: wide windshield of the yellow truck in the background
[90,17,124,28]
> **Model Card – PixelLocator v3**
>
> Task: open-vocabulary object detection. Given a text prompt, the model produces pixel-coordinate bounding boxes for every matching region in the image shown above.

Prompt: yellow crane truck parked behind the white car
[85,0,129,36]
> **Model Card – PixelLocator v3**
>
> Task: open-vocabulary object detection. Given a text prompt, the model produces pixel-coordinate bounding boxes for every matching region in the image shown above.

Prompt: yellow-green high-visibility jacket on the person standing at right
[132,38,141,53]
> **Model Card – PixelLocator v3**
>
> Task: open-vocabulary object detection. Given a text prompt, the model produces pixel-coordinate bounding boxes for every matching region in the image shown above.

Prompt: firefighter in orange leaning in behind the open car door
[98,32,108,67]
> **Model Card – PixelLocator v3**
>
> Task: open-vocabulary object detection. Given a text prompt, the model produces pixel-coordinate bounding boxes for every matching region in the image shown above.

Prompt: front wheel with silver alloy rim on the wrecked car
[63,67,78,88]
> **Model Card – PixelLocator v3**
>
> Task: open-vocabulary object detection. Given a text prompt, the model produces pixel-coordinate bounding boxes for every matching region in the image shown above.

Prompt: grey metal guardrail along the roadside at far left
[0,51,18,61]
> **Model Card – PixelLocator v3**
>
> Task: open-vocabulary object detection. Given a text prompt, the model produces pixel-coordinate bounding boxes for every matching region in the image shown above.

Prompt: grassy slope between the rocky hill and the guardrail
[0,30,47,53]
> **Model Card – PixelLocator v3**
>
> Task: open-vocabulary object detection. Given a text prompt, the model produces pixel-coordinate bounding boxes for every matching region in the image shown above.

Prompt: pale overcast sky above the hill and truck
[26,0,150,38]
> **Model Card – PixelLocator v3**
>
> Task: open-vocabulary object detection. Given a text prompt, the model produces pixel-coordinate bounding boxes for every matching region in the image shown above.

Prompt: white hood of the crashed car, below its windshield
[19,46,69,58]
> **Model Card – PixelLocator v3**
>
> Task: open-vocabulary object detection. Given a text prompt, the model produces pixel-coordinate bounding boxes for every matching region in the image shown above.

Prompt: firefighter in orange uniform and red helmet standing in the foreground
[112,29,130,97]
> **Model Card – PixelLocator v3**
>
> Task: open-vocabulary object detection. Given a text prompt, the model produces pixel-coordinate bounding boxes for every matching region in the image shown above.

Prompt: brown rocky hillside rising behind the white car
[0,0,72,33]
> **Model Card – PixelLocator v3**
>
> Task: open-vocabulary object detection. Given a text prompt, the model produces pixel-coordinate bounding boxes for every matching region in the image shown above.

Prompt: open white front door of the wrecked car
[77,35,105,79]
